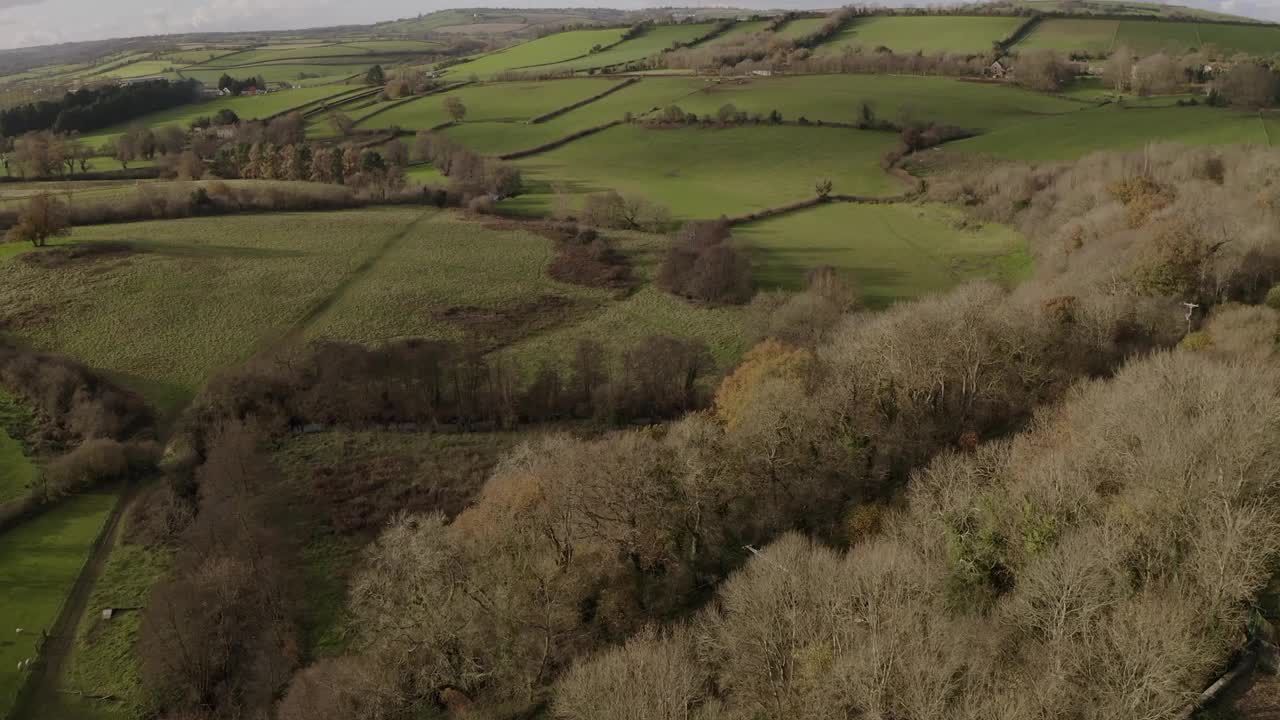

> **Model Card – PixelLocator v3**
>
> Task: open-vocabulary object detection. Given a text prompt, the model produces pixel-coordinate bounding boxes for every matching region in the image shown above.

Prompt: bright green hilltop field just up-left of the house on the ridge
[817,15,1027,54]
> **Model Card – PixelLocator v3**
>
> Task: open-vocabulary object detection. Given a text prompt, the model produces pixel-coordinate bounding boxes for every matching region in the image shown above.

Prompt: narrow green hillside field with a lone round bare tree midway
[360,78,618,129]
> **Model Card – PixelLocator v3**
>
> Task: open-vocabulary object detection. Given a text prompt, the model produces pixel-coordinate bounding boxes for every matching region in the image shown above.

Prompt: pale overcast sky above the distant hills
[0,0,1280,47]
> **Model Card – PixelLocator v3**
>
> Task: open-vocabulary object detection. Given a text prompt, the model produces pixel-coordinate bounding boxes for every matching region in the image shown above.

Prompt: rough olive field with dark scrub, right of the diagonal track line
[299,207,746,370]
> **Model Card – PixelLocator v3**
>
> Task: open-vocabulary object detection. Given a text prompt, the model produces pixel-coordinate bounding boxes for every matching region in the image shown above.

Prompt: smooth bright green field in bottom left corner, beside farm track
[0,493,115,714]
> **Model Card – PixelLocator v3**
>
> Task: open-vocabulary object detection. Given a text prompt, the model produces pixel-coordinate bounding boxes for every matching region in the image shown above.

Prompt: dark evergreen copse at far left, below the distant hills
[0,79,196,137]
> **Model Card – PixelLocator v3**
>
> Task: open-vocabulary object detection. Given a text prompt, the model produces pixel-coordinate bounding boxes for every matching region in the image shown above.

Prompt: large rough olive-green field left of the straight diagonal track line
[0,208,424,413]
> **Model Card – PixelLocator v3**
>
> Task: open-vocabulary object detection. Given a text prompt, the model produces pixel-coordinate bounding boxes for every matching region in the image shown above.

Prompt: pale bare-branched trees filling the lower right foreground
[553,330,1280,720]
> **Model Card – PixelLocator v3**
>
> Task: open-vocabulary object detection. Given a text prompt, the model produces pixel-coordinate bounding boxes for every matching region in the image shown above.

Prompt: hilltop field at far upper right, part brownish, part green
[1015,18,1280,56]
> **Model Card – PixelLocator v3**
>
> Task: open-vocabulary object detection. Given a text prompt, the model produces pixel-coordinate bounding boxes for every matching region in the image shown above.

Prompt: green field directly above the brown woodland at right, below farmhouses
[947,105,1267,161]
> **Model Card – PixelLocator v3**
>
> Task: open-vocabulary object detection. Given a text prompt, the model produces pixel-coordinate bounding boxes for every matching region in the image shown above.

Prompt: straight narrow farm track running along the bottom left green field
[9,483,140,720]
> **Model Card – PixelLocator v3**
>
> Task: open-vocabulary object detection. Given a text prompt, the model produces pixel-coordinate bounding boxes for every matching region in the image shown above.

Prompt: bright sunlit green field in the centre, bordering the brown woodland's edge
[735,202,1030,307]
